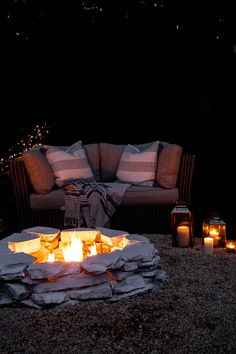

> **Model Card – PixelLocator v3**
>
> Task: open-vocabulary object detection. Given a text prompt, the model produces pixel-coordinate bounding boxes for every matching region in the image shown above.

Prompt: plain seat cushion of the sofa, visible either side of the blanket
[30,186,179,210]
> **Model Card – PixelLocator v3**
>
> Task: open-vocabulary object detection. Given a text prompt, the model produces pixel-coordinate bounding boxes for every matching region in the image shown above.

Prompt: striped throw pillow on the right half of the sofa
[116,141,159,186]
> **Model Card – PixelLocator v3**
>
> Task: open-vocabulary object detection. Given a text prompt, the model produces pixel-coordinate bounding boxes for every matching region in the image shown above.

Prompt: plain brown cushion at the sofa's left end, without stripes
[22,149,54,193]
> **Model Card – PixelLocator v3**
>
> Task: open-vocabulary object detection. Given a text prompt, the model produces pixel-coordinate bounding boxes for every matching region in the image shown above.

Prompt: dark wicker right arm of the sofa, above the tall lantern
[177,154,196,206]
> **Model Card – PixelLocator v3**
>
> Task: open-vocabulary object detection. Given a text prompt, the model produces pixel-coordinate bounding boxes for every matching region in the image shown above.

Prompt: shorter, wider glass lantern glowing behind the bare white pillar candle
[202,215,226,247]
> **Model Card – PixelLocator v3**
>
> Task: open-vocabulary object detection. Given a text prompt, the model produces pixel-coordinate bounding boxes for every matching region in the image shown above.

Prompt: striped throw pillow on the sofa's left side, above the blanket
[46,141,94,187]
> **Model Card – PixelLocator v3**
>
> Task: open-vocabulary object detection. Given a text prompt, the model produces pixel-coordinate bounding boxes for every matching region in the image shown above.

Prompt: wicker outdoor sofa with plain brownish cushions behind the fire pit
[10,142,195,233]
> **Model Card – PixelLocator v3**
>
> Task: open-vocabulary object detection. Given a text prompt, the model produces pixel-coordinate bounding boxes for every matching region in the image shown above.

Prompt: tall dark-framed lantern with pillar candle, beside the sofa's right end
[171,201,194,247]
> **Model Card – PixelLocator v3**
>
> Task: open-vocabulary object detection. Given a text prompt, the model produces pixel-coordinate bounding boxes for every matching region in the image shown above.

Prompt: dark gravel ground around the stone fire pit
[0,235,236,354]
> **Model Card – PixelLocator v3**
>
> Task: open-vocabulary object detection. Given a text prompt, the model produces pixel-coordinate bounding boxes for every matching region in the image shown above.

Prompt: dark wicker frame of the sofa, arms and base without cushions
[10,154,195,233]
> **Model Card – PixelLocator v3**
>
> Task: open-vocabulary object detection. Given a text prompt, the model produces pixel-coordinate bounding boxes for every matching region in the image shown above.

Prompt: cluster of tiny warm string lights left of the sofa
[0,123,49,175]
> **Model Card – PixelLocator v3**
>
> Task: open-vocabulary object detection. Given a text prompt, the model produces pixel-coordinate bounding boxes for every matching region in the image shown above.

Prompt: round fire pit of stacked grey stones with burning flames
[0,226,166,309]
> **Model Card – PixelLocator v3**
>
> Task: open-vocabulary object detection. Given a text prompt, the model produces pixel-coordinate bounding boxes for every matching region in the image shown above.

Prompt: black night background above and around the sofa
[0,0,236,238]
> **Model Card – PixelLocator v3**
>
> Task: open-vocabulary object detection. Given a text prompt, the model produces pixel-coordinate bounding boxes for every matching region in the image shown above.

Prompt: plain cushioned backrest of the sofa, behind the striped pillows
[20,142,183,193]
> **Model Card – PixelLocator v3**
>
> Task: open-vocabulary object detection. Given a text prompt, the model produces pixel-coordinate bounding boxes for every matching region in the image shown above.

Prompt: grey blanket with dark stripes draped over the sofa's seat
[64,181,130,228]
